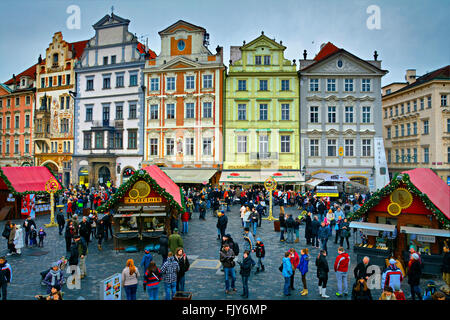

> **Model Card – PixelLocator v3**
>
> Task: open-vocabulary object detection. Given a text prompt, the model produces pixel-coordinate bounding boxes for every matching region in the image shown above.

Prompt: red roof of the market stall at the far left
[0,167,62,192]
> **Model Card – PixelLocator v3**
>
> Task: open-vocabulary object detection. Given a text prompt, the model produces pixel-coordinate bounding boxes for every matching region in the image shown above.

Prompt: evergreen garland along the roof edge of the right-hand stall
[348,173,450,230]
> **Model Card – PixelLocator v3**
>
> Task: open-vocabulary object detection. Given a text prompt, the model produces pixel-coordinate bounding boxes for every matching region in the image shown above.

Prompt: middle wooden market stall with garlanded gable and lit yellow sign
[97,165,184,250]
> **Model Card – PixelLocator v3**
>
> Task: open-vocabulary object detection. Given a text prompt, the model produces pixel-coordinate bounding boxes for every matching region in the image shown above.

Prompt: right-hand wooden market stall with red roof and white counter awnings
[350,168,450,274]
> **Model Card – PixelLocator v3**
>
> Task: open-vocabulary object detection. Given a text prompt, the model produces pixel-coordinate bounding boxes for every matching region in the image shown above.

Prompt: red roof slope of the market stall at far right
[402,168,450,219]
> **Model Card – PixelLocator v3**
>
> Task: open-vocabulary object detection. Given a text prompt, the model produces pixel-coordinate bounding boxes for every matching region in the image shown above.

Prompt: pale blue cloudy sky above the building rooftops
[0,0,450,85]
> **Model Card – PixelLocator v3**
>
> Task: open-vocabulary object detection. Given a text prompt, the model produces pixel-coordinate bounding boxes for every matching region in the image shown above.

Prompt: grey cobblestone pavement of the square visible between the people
[0,205,442,300]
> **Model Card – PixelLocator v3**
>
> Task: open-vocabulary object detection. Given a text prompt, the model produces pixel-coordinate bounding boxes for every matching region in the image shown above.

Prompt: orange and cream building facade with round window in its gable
[144,20,225,183]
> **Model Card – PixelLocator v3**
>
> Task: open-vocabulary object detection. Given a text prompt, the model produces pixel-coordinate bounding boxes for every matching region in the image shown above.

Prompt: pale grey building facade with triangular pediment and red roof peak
[299,42,389,191]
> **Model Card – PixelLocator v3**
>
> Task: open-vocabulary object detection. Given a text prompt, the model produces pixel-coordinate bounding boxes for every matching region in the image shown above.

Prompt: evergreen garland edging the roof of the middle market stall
[97,169,185,213]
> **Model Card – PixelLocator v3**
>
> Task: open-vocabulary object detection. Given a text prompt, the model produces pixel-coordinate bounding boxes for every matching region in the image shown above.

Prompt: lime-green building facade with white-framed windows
[221,32,304,184]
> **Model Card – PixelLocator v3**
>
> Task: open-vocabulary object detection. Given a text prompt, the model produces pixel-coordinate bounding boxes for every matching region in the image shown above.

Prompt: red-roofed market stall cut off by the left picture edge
[0,166,62,220]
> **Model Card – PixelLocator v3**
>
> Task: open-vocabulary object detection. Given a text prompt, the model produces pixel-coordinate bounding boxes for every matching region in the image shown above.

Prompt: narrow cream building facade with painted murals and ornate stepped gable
[33,32,87,186]
